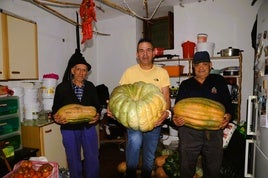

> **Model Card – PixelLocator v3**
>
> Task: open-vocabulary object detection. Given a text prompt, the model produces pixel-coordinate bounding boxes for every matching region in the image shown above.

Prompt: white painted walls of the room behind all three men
[0,0,262,120]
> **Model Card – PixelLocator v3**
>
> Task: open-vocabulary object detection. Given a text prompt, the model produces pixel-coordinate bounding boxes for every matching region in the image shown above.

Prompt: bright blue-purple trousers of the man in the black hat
[61,126,100,178]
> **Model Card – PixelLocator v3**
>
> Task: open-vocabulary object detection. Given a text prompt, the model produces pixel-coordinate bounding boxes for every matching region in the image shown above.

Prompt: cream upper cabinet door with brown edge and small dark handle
[7,15,38,79]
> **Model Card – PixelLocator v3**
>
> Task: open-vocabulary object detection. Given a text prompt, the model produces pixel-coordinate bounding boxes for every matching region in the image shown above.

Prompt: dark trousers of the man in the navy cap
[179,127,223,178]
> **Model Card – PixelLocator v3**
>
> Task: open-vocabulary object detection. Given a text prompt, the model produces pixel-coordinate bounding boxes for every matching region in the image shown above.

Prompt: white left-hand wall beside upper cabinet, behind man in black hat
[0,0,97,83]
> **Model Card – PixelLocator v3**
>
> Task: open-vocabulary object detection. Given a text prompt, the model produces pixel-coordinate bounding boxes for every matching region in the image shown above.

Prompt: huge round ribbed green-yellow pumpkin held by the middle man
[109,82,166,132]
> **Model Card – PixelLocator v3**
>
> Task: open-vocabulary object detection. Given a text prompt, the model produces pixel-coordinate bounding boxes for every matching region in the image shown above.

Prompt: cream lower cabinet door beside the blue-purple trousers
[40,123,67,168]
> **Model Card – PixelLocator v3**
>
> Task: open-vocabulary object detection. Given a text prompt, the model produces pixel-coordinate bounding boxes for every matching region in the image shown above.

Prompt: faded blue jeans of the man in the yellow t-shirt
[126,127,161,178]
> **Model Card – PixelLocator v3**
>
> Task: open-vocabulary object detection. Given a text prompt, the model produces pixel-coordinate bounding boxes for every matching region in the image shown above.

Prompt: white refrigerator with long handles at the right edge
[244,0,268,178]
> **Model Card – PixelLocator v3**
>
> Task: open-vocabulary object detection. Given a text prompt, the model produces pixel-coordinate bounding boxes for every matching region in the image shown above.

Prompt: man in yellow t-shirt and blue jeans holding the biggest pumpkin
[112,39,171,178]
